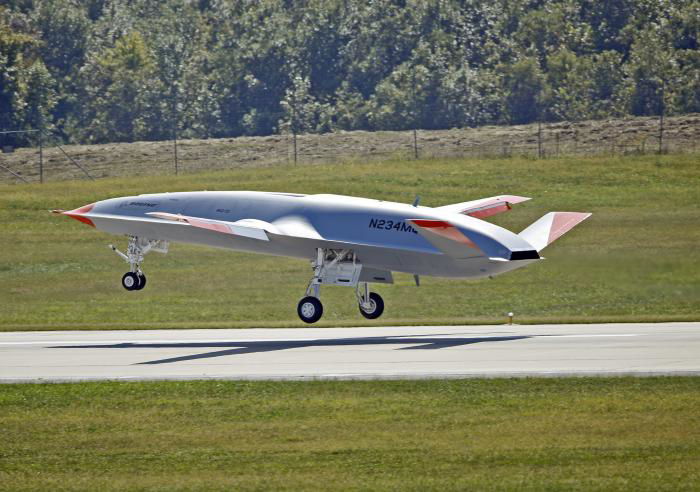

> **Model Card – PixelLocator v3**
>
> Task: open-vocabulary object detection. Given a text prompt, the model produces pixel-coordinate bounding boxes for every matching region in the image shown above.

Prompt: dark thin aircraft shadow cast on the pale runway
[50,335,531,365]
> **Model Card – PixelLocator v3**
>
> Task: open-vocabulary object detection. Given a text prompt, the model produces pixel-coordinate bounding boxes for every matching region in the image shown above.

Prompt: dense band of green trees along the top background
[0,0,700,145]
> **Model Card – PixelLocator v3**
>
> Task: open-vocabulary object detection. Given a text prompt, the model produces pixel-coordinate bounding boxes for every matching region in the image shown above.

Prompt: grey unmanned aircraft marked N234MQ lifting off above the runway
[53,191,591,323]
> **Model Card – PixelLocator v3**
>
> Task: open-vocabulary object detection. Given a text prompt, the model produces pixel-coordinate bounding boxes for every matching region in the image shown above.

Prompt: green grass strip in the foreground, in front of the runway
[0,378,700,491]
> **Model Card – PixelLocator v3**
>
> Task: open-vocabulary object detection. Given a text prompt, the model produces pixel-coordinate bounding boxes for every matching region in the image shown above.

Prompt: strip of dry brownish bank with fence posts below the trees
[0,114,700,184]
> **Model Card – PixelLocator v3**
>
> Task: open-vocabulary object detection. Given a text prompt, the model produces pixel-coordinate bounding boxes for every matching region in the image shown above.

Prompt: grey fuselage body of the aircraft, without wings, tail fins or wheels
[86,191,536,278]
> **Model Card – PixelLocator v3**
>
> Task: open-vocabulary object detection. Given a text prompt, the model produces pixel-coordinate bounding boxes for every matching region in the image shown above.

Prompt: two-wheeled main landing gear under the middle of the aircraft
[297,248,384,323]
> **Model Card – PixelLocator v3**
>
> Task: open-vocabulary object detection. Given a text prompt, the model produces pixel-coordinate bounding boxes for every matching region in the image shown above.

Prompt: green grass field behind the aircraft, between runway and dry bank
[0,155,700,330]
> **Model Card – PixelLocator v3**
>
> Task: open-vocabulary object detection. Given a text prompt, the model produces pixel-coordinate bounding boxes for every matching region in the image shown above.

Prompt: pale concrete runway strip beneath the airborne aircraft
[0,323,700,383]
